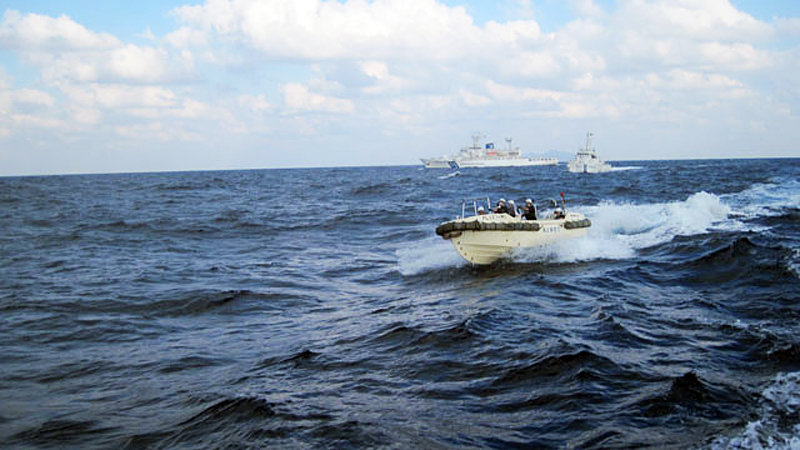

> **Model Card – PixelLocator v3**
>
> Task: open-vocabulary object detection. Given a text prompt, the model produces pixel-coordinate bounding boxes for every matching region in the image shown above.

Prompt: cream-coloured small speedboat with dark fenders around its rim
[436,212,591,264]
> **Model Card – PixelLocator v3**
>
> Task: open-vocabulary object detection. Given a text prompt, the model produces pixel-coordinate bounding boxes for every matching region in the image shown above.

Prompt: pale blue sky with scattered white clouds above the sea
[0,0,800,176]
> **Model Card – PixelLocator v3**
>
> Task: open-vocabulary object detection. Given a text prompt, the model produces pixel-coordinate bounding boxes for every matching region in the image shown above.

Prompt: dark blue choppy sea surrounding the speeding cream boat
[0,159,800,448]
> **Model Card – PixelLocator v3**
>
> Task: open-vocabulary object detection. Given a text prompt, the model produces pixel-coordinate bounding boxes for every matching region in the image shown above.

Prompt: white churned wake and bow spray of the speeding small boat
[397,180,800,275]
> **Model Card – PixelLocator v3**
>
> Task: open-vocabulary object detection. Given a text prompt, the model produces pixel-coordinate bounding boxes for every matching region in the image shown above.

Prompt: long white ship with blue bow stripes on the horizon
[421,134,558,169]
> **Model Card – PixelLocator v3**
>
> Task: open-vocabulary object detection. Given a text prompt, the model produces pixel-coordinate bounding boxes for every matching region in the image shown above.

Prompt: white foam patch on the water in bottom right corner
[711,372,800,449]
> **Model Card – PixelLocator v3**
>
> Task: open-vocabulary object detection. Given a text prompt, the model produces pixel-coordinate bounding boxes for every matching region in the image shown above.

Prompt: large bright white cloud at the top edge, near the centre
[174,0,520,61]
